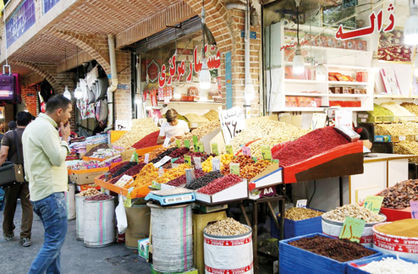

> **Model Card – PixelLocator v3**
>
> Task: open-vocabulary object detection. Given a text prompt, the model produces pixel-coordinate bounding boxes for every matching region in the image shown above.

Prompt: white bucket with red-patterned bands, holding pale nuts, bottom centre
[203,226,254,273]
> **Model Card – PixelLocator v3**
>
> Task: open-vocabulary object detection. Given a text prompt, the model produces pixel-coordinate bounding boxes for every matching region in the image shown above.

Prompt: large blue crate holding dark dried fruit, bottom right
[279,233,382,274]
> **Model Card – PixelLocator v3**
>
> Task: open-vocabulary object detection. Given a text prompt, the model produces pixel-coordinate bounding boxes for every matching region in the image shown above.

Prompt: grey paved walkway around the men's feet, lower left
[0,199,150,274]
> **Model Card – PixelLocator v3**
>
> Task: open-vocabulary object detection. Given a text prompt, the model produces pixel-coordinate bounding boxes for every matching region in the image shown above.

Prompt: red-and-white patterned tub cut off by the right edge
[373,222,418,261]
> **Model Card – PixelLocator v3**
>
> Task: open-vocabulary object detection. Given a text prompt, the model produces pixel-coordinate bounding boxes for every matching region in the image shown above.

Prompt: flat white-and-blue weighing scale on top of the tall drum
[145,188,196,206]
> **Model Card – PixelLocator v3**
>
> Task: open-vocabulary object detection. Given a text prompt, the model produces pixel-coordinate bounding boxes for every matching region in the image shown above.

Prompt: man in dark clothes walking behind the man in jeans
[0,111,33,247]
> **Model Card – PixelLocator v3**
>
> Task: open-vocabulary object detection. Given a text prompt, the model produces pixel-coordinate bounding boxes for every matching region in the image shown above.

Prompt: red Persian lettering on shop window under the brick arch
[158,45,221,88]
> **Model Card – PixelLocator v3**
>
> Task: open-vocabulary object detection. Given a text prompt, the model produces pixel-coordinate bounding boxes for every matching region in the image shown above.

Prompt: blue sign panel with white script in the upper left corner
[6,0,36,47]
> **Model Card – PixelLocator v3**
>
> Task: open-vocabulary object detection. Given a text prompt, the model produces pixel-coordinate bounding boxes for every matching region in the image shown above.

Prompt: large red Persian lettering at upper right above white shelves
[335,4,395,40]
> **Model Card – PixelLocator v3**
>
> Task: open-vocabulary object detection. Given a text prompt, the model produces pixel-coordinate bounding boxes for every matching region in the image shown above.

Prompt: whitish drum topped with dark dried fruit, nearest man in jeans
[82,197,115,247]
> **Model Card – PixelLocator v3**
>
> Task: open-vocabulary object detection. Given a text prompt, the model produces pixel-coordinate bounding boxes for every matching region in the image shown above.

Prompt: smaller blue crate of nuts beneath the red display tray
[270,209,322,239]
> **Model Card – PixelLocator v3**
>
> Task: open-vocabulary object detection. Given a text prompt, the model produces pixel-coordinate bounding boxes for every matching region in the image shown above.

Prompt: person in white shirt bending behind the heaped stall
[157,109,190,146]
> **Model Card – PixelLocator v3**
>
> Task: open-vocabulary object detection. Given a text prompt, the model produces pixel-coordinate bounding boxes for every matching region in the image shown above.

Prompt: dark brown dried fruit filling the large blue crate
[289,235,376,262]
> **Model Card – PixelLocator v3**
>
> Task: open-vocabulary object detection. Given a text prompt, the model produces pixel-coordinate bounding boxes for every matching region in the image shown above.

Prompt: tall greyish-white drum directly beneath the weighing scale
[147,203,193,272]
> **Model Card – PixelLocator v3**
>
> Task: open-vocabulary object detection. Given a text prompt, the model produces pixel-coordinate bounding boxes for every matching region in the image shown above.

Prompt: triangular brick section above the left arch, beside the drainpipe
[50,28,111,74]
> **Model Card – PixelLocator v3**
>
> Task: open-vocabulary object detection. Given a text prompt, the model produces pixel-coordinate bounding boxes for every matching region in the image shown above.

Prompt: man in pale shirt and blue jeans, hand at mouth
[22,95,72,273]
